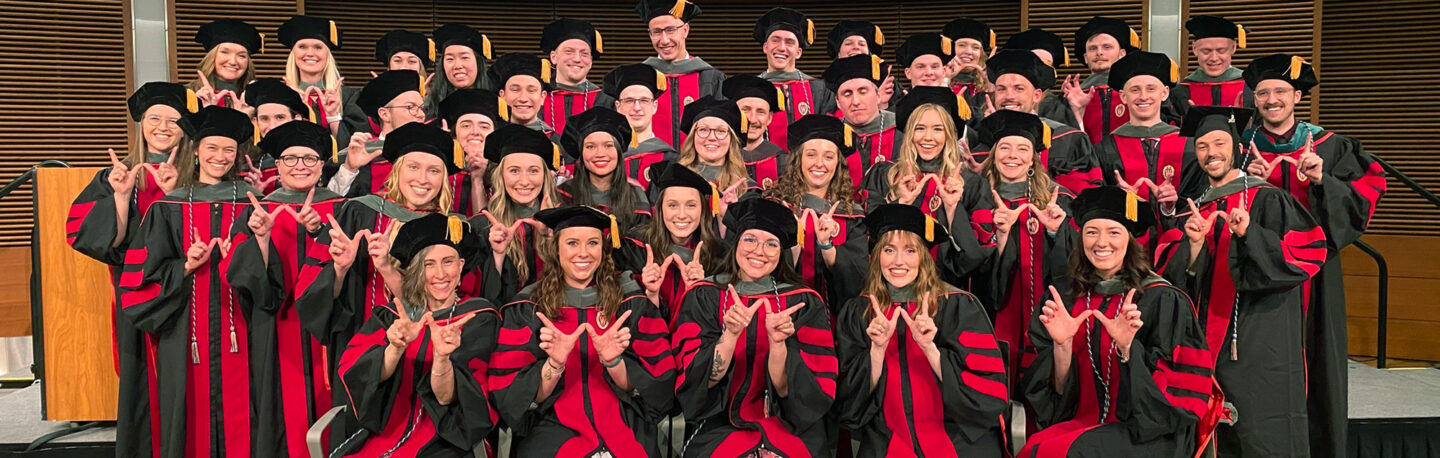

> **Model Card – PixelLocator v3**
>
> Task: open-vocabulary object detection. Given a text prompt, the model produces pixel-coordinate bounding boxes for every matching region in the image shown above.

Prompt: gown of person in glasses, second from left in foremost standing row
[226,187,344,457]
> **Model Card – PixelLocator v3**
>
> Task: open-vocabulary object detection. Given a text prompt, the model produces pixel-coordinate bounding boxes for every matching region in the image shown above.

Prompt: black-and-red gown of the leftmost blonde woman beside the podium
[65,153,167,457]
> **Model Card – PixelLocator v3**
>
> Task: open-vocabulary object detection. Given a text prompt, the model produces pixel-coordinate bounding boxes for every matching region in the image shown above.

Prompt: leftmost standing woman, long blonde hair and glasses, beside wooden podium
[65,82,199,457]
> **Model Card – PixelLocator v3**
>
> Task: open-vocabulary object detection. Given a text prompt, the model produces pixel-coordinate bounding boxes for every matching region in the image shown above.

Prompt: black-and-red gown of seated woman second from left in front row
[490,277,675,457]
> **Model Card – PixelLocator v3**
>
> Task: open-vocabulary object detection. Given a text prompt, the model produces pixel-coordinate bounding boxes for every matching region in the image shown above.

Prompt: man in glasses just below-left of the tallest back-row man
[602,63,680,189]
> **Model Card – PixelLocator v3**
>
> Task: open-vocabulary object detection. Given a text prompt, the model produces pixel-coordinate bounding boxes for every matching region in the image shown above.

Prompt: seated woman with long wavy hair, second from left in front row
[490,206,675,457]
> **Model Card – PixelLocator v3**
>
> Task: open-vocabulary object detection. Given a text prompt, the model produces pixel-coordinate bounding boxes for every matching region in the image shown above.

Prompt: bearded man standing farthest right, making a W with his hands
[1241,55,1385,457]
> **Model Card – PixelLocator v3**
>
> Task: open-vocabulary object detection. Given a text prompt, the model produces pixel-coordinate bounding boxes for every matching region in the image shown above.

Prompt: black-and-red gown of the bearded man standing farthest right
[1244,122,1385,457]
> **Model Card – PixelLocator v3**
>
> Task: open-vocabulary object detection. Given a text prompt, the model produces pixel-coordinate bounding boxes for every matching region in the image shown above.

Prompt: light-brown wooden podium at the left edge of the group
[32,167,120,422]
